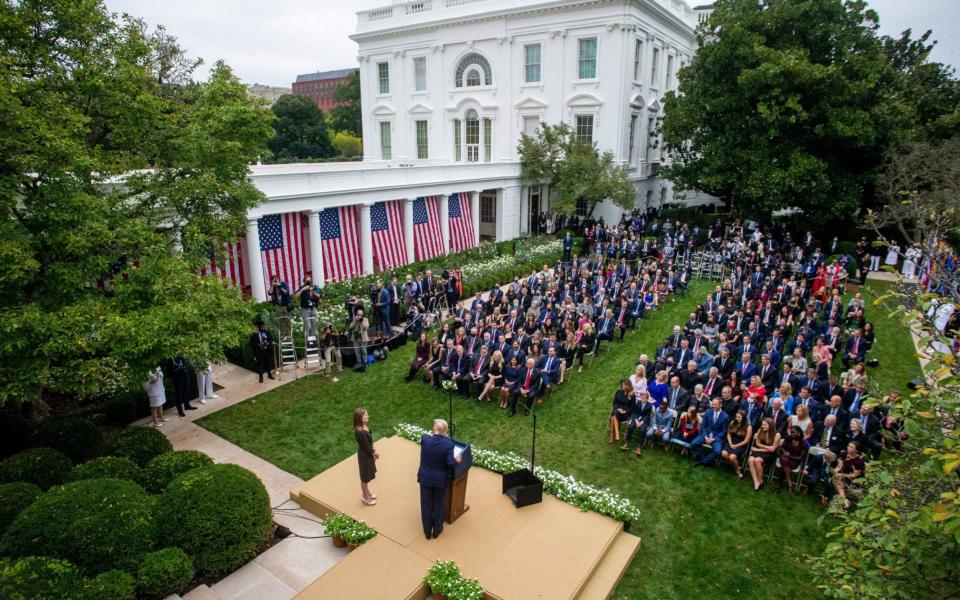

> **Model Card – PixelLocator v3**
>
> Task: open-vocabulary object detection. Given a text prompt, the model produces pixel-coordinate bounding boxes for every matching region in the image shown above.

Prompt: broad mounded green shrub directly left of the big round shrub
[3,479,155,573]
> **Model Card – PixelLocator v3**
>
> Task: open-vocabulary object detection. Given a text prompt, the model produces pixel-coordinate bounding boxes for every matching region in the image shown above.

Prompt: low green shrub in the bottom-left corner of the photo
[0,556,83,600]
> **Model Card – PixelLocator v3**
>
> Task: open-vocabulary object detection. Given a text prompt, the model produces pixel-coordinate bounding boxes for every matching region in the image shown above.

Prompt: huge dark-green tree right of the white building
[663,0,955,224]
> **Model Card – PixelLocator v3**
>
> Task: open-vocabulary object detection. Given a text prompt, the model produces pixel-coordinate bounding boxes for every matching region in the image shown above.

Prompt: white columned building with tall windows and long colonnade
[248,0,698,297]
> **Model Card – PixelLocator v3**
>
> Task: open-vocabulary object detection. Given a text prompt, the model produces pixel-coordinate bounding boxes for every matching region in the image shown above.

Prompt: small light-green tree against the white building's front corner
[517,123,637,214]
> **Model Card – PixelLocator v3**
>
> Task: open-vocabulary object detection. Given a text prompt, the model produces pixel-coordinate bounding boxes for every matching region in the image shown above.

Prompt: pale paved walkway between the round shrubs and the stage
[138,363,347,600]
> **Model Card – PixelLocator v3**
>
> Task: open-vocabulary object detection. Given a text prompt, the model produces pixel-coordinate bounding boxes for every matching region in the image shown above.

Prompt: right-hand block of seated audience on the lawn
[600,214,906,503]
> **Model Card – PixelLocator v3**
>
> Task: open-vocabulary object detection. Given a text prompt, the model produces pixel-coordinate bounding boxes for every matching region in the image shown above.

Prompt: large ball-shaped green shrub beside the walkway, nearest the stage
[157,465,271,575]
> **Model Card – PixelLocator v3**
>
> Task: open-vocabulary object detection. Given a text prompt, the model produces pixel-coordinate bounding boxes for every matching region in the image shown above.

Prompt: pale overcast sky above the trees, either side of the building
[105,0,960,87]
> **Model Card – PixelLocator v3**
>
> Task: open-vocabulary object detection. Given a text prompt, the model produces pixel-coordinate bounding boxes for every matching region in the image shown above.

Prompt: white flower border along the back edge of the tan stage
[394,423,640,522]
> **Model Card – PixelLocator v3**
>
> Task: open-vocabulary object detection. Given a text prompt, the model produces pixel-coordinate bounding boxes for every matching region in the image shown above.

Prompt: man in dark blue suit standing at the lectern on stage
[417,419,461,540]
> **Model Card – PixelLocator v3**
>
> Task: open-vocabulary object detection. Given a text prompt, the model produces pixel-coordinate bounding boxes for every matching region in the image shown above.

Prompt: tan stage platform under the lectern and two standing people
[291,437,640,600]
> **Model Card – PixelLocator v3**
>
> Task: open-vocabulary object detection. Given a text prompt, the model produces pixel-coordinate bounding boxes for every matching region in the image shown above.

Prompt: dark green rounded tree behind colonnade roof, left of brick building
[267,94,336,159]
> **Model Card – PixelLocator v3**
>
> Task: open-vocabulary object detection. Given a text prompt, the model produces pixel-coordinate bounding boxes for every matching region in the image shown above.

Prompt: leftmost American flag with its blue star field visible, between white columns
[257,213,307,288]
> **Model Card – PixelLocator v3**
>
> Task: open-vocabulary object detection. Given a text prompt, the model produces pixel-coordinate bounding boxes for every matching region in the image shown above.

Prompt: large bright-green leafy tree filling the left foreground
[0,0,273,403]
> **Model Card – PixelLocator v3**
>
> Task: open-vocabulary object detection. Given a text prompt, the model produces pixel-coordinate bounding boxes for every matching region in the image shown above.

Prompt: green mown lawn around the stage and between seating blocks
[200,282,912,598]
